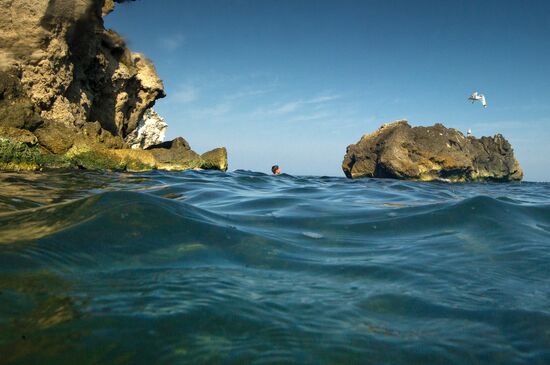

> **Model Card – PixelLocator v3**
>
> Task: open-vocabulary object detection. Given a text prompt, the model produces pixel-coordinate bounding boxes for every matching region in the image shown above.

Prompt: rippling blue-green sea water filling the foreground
[0,171,550,364]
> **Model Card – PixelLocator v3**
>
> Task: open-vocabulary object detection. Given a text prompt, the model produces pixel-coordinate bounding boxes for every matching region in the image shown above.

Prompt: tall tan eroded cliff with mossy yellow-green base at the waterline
[0,0,227,169]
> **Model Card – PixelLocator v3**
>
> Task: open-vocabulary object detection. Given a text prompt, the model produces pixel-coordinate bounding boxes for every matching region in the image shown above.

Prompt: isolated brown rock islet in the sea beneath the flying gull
[342,120,523,181]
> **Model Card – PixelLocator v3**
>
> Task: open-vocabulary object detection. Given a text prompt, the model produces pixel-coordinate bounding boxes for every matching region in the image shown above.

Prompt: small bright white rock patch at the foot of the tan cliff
[126,108,168,149]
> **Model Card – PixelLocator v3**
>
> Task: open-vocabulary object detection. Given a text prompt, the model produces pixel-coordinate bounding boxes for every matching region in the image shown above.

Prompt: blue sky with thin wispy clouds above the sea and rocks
[105,0,550,181]
